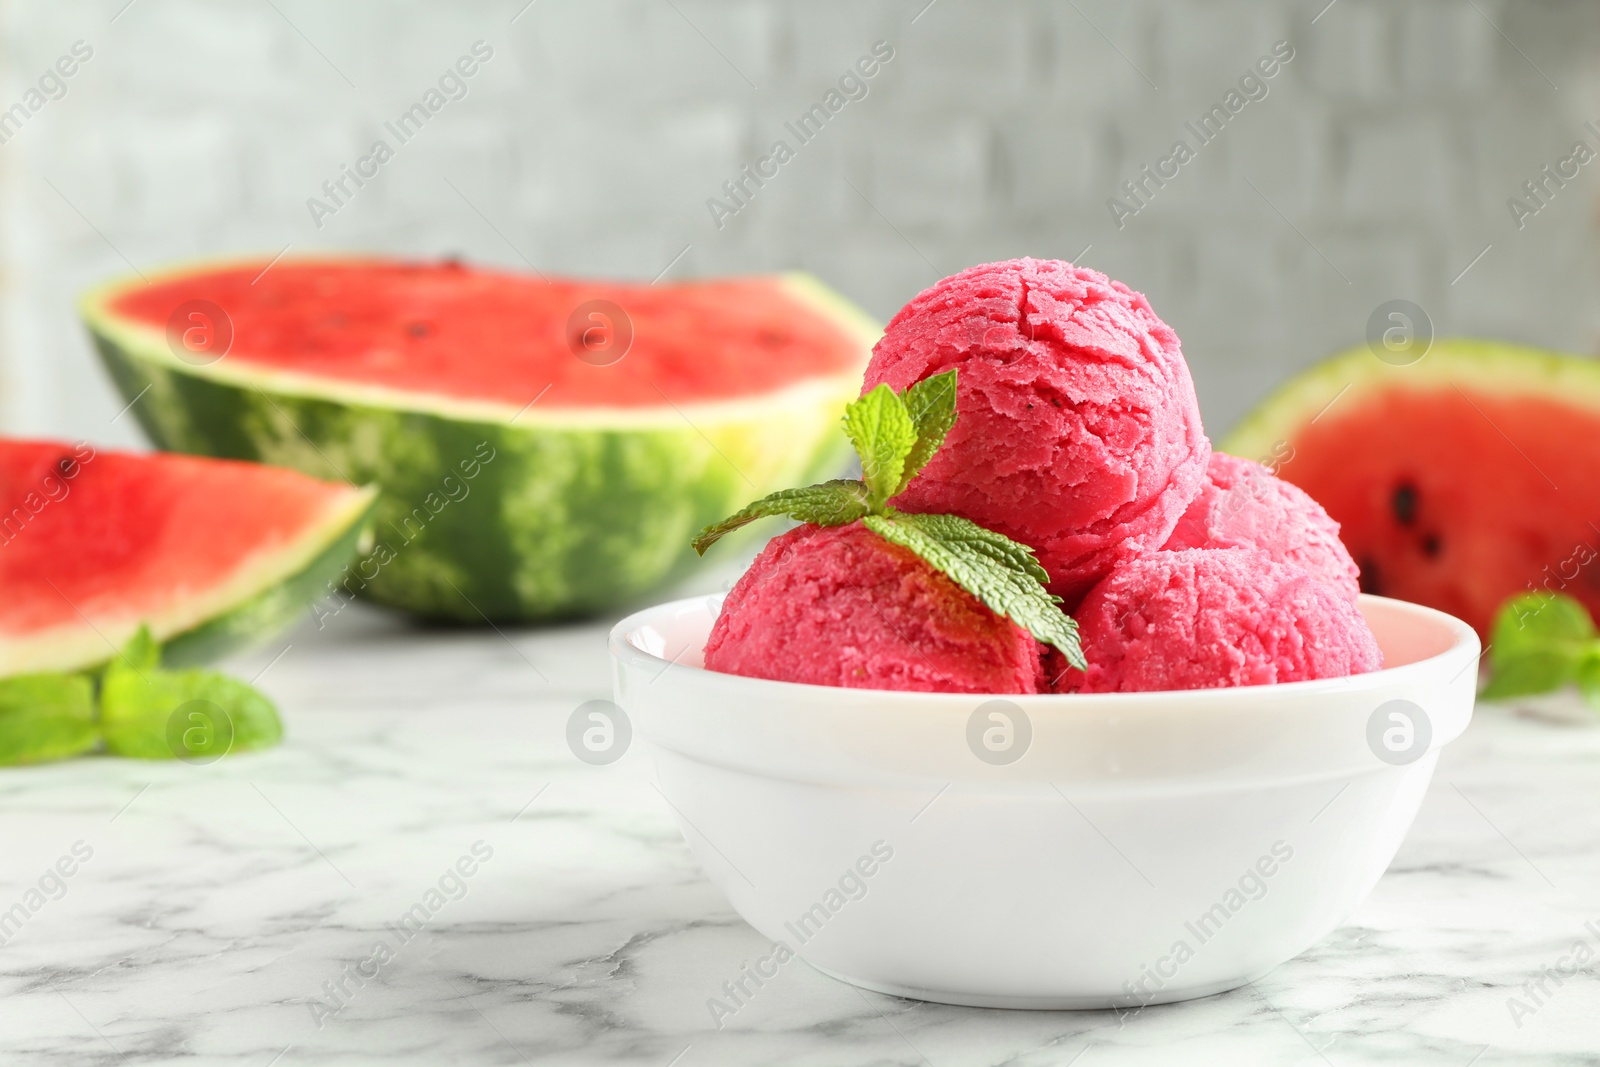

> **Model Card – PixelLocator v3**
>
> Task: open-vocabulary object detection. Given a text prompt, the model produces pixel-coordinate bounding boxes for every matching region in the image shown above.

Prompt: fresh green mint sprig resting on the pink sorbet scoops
[693,370,1086,670]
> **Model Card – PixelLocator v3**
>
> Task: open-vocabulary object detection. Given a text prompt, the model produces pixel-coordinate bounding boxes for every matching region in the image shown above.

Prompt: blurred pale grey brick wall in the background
[0,0,1600,443]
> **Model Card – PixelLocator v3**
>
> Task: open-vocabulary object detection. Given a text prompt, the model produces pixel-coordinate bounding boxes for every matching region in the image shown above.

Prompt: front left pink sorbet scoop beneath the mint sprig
[706,523,1043,693]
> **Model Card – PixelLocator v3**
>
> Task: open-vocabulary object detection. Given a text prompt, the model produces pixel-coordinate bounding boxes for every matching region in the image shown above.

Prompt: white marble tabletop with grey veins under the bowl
[0,588,1600,1067]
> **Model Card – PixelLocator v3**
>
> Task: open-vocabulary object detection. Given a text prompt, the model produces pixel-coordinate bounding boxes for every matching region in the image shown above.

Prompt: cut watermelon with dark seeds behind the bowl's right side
[1221,341,1600,637]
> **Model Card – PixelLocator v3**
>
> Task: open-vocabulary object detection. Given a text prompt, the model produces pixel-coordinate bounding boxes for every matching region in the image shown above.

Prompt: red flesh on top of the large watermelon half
[110,261,861,408]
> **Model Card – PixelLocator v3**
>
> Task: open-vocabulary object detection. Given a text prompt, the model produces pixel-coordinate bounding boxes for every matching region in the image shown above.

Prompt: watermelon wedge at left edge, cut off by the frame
[0,440,376,675]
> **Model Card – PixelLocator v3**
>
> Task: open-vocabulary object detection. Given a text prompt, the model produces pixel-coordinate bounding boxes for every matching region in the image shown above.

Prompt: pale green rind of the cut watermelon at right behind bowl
[1218,338,1600,459]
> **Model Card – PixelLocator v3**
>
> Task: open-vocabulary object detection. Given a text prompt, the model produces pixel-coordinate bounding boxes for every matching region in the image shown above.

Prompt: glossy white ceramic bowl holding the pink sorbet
[611,597,1478,1008]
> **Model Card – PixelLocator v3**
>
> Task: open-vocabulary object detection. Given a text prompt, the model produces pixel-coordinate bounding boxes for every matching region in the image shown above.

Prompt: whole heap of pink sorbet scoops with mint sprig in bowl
[702,259,1382,694]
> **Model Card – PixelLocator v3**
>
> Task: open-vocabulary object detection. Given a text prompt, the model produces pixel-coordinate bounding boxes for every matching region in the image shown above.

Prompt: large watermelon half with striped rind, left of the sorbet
[82,259,880,622]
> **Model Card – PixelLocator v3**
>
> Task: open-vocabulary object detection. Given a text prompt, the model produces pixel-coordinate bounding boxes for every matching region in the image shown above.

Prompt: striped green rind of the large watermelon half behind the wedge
[82,267,880,622]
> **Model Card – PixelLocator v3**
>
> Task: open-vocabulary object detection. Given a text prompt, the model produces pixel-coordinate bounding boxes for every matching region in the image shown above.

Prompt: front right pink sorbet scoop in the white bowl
[1061,549,1382,693]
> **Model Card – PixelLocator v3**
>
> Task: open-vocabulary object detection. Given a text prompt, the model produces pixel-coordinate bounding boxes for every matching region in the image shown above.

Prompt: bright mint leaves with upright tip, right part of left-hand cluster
[101,629,283,763]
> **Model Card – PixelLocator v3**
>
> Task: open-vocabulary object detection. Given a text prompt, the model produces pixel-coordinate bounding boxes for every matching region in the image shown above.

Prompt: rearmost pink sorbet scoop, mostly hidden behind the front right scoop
[1166,453,1362,600]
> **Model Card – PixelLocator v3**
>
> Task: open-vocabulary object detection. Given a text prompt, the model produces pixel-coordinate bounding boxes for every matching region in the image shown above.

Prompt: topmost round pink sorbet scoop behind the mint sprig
[862,259,1211,608]
